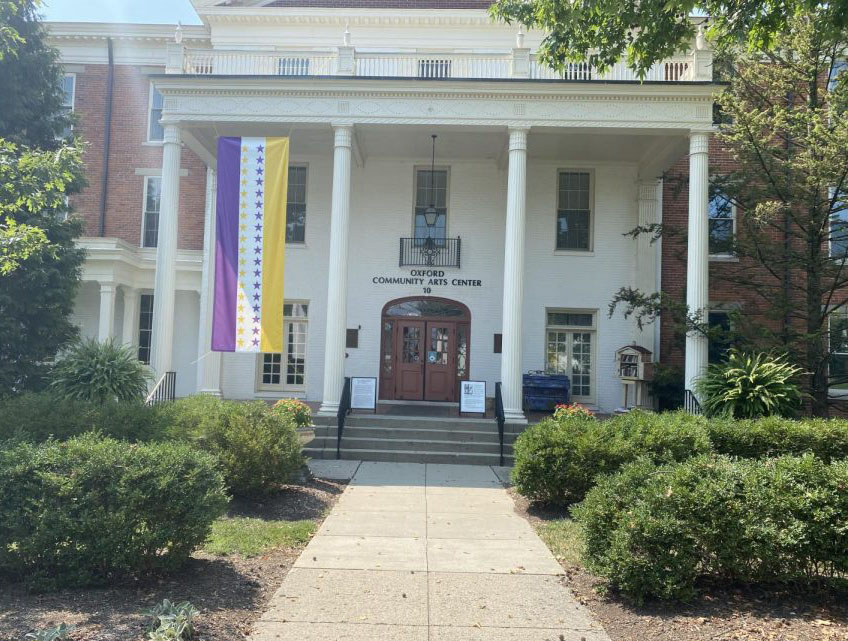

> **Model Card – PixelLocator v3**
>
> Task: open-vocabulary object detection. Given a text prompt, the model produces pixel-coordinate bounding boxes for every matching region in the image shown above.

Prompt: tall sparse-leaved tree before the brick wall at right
[610,11,848,416]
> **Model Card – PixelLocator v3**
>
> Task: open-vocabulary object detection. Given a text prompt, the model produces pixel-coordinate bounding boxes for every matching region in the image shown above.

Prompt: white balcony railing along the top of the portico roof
[168,45,712,82]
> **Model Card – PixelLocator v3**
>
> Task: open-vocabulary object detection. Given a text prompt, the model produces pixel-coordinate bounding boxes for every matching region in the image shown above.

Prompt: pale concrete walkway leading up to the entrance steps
[250,463,609,641]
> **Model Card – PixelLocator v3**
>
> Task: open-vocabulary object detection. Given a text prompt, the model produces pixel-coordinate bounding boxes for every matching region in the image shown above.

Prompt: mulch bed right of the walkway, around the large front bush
[511,492,848,641]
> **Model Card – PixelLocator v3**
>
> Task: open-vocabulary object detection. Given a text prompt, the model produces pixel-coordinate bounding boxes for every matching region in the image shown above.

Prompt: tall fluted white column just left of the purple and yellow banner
[150,125,181,377]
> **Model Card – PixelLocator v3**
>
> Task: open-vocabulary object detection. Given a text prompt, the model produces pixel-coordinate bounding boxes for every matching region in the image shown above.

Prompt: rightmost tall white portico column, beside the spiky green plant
[686,132,710,391]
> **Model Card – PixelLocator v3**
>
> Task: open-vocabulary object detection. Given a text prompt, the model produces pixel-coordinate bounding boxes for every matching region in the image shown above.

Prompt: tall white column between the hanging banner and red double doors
[320,125,353,414]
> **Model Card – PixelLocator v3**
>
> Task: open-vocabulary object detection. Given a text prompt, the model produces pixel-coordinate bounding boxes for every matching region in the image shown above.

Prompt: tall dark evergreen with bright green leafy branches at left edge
[0,0,84,394]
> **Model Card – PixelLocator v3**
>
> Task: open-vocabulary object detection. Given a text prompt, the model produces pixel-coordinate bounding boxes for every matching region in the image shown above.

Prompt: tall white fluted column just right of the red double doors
[501,129,527,421]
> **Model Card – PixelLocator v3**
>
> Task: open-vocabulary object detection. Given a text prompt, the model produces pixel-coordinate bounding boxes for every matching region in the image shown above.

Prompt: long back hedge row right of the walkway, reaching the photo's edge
[512,411,848,505]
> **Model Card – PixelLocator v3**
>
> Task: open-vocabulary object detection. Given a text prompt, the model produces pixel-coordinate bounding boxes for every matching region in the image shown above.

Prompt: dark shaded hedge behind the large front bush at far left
[0,392,169,443]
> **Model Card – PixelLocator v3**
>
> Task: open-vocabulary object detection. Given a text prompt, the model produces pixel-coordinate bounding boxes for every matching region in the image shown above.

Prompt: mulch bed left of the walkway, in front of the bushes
[0,472,344,641]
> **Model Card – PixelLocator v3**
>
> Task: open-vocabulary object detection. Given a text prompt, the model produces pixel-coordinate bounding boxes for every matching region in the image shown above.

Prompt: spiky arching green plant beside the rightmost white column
[695,350,802,418]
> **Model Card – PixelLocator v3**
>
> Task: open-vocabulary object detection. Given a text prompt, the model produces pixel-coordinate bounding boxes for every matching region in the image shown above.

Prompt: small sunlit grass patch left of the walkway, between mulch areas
[203,517,315,558]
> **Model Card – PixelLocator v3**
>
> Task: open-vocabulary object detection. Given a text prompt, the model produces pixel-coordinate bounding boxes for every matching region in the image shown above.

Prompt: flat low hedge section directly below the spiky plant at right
[707,416,848,462]
